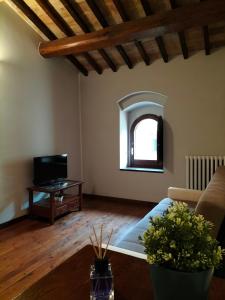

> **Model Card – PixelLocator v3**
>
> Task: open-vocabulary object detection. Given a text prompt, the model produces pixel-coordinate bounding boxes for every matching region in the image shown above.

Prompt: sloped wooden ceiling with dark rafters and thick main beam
[6,0,225,75]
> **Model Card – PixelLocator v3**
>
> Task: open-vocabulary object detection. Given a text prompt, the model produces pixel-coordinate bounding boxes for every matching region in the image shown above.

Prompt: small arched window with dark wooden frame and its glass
[128,114,163,169]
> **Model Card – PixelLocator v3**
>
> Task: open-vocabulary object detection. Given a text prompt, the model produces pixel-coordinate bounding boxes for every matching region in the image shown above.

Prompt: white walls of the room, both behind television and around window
[0,3,225,223]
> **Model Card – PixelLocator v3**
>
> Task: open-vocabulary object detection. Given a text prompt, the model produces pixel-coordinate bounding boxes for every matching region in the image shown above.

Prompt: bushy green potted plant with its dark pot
[140,202,224,300]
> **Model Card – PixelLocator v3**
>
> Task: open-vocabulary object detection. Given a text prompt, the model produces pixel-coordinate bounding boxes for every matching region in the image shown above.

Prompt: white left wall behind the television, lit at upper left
[0,3,80,223]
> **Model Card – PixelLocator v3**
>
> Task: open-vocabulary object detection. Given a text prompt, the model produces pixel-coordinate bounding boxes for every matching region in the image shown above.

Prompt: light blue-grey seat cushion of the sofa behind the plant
[116,198,173,253]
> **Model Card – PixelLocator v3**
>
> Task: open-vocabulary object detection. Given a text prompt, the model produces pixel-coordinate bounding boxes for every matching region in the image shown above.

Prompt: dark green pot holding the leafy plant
[150,265,213,300]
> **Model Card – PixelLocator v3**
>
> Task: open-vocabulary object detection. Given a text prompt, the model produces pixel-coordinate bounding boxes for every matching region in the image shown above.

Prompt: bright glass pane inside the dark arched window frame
[134,119,158,160]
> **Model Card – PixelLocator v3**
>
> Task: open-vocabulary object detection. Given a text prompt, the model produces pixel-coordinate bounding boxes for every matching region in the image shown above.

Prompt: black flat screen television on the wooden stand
[33,154,67,186]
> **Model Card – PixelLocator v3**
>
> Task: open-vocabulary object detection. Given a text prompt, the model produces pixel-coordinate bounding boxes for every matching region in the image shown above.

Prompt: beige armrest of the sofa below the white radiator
[168,187,203,205]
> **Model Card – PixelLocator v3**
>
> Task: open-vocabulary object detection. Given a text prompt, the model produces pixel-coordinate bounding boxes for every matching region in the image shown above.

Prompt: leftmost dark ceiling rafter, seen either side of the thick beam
[11,0,88,76]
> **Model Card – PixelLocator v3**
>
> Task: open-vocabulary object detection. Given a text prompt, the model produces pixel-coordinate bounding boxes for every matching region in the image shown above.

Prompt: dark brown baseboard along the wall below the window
[83,193,157,208]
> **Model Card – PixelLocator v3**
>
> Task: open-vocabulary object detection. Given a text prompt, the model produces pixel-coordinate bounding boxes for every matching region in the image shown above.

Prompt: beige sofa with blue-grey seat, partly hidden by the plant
[116,167,225,253]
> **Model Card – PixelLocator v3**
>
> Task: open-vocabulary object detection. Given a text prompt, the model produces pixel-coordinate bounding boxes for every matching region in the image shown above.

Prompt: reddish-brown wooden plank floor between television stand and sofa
[0,199,152,300]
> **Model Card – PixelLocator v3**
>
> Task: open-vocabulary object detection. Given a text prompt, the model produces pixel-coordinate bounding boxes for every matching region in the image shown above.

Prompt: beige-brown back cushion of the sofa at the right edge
[195,166,225,238]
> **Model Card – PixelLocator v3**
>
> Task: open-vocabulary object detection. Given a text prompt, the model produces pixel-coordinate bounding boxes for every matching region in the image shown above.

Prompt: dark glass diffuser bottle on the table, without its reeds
[90,258,114,300]
